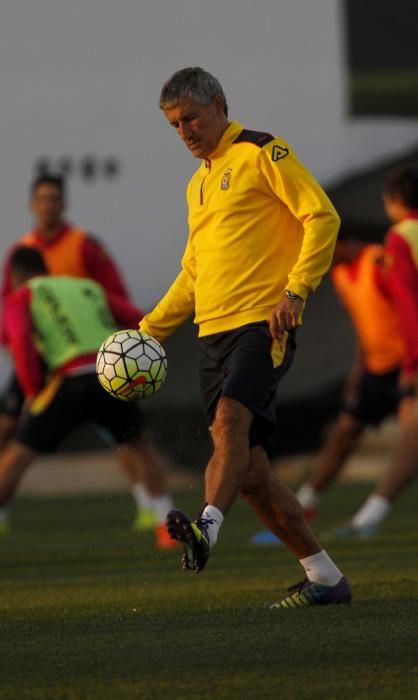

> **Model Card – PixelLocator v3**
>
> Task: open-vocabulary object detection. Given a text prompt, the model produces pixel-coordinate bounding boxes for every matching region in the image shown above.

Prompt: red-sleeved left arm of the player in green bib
[4,287,44,399]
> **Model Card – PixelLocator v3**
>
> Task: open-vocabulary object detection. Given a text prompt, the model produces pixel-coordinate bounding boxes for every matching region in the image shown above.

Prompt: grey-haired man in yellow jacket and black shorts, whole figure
[140,68,351,607]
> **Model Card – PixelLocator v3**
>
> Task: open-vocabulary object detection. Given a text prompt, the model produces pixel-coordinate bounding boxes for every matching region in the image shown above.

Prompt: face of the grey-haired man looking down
[164,97,228,158]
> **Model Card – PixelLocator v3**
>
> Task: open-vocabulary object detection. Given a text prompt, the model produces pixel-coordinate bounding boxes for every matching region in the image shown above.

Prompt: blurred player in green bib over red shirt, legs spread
[0,247,176,548]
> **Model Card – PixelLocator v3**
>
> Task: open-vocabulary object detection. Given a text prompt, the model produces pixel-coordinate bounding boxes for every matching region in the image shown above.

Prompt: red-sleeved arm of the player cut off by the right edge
[382,231,418,376]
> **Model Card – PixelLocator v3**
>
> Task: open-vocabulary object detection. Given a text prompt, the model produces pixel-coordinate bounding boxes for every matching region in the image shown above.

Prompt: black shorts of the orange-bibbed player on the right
[343,369,402,427]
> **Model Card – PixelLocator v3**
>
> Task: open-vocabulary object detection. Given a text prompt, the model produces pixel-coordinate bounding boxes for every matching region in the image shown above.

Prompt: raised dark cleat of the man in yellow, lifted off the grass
[166,510,210,574]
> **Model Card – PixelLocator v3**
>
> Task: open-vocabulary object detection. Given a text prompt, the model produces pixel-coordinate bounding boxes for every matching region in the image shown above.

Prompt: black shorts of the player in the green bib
[16,373,142,452]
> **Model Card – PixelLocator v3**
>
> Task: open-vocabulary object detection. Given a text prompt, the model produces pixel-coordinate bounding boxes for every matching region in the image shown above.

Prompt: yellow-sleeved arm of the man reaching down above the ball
[140,241,195,342]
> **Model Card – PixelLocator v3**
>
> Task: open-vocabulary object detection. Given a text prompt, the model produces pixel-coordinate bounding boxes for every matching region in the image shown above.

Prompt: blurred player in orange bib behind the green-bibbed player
[0,174,170,531]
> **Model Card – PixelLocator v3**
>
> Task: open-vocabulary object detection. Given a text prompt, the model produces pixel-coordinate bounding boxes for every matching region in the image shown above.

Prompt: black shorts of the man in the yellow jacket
[198,321,296,456]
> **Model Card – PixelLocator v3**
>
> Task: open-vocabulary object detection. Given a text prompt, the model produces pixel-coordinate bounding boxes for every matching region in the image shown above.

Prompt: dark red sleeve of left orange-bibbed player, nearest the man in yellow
[82,236,129,299]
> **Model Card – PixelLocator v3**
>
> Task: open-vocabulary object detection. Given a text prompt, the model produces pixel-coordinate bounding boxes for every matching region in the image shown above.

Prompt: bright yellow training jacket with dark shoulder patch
[141,122,340,340]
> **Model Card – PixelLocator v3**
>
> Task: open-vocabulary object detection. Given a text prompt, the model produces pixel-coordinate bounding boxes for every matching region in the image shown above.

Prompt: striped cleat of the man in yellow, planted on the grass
[269,576,352,610]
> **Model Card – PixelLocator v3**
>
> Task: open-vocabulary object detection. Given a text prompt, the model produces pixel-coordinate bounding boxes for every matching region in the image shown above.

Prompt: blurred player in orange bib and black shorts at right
[250,238,404,545]
